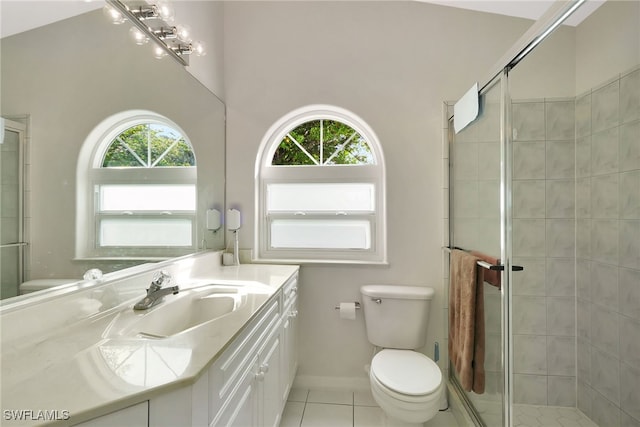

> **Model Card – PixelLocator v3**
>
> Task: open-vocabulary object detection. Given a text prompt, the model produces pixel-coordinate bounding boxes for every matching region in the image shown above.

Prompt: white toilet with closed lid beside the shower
[360,285,446,426]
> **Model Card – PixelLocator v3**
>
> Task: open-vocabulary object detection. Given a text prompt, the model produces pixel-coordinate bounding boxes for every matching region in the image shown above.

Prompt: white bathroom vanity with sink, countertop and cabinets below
[0,252,298,427]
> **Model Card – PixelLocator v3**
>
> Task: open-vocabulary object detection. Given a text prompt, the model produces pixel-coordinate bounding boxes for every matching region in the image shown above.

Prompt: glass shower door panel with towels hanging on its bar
[449,75,510,426]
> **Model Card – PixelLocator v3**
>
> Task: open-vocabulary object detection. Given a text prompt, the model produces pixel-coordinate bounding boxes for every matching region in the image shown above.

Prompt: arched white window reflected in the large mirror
[76,111,197,257]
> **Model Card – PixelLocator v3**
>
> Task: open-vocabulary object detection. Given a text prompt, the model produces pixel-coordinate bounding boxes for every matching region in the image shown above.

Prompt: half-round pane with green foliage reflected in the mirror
[101,124,196,168]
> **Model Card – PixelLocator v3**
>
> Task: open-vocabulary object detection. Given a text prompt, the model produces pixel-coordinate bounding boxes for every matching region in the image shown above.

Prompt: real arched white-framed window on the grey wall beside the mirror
[256,105,386,262]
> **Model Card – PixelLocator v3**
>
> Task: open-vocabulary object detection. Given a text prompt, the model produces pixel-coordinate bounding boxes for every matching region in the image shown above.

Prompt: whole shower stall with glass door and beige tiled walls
[445,0,640,427]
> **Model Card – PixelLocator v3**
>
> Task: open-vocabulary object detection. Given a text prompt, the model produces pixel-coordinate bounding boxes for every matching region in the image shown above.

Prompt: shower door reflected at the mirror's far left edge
[0,121,24,299]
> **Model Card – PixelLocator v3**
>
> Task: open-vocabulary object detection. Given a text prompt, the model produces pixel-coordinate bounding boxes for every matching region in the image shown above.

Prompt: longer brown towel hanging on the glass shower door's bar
[449,249,485,394]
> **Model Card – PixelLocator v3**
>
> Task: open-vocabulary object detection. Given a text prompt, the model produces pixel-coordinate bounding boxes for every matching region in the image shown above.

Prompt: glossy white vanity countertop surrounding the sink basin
[0,256,298,426]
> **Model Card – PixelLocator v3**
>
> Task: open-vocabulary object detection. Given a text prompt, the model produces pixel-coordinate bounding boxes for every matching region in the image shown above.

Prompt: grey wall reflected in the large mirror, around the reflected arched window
[0,8,225,298]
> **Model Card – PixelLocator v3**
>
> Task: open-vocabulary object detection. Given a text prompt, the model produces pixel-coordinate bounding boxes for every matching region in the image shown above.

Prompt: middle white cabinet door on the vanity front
[257,331,282,427]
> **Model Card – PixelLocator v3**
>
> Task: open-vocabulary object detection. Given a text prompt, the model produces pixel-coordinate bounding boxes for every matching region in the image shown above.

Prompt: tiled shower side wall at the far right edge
[576,68,640,426]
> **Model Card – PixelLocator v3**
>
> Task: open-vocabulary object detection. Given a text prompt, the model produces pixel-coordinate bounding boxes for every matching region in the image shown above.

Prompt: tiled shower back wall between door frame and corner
[512,98,576,406]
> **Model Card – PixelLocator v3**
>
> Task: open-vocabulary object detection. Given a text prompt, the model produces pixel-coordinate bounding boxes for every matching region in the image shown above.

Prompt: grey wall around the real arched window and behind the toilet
[225,1,531,385]
